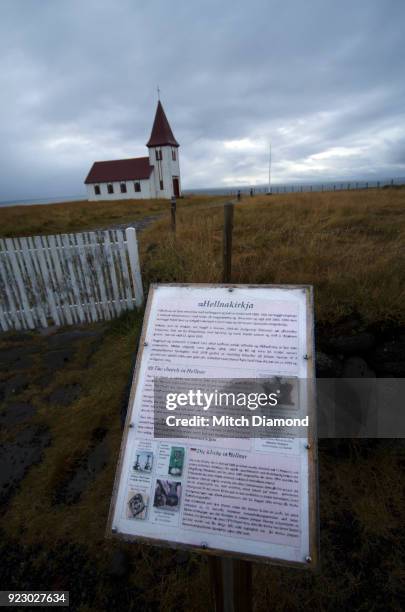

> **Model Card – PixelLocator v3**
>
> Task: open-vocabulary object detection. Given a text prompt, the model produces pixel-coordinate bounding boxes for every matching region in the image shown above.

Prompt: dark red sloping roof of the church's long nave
[84,157,153,183]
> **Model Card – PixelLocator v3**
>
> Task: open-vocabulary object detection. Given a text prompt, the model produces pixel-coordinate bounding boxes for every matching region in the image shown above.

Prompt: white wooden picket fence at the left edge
[0,228,143,331]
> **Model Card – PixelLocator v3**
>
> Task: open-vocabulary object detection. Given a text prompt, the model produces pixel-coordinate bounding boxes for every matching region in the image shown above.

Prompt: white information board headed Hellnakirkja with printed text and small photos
[107,284,318,567]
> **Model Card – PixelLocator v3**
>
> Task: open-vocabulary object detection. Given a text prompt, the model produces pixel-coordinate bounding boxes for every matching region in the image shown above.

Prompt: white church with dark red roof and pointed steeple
[84,100,181,201]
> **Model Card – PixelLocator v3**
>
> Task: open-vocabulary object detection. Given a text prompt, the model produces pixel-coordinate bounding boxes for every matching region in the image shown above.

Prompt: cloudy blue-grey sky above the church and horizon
[0,0,405,201]
